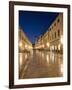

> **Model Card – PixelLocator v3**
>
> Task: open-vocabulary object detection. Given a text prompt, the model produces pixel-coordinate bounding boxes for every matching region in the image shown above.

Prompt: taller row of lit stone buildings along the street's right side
[35,13,63,52]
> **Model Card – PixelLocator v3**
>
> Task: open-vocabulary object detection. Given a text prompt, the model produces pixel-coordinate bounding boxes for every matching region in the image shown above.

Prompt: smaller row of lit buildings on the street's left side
[18,28,32,52]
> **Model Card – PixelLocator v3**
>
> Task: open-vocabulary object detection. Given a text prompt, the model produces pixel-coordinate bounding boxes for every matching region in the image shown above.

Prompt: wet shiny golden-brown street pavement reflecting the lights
[19,50,63,79]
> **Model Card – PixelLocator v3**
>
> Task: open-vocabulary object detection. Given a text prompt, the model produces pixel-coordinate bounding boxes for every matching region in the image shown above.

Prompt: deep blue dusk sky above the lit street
[19,11,59,44]
